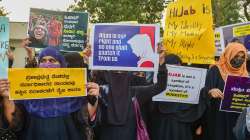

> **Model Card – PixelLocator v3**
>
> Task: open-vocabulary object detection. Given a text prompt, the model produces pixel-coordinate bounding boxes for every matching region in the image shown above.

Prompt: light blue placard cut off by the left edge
[0,16,9,79]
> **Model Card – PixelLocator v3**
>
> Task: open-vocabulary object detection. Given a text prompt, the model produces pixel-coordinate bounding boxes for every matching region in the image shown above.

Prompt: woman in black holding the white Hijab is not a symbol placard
[148,54,206,140]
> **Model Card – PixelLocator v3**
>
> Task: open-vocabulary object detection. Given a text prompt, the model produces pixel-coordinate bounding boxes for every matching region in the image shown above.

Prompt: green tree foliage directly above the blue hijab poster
[69,0,172,23]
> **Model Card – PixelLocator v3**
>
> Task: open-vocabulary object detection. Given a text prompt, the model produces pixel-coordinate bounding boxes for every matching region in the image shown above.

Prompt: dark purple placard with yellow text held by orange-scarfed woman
[220,75,250,113]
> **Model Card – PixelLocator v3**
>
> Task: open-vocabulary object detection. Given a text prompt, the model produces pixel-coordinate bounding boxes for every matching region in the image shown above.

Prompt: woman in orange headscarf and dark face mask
[202,43,248,140]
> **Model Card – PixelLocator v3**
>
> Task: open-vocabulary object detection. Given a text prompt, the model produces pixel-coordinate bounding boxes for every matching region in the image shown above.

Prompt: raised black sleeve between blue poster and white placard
[132,65,167,106]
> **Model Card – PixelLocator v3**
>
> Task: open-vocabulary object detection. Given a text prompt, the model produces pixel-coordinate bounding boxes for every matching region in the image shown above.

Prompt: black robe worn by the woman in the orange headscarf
[203,66,239,140]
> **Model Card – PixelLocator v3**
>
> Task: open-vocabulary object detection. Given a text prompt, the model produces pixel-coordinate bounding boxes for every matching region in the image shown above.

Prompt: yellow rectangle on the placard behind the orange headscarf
[233,25,250,37]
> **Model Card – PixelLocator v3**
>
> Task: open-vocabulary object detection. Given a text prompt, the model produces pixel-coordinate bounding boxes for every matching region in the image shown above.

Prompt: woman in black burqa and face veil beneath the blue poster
[97,47,167,140]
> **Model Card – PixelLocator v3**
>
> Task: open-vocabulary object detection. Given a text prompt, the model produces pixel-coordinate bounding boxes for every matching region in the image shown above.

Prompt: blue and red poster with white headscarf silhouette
[90,23,160,71]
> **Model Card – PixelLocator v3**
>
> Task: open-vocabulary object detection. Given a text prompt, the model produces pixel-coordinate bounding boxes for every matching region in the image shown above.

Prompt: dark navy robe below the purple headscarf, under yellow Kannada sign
[18,115,84,140]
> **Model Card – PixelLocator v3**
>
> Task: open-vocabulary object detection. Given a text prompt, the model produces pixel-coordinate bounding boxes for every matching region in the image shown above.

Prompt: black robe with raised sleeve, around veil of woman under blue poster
[96,65,167,140]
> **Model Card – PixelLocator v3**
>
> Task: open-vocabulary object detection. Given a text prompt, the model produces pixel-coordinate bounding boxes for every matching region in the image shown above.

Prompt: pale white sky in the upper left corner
[0,0,74,22]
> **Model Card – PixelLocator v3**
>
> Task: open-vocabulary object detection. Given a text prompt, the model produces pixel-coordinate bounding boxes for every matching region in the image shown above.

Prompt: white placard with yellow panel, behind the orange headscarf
[220,22,250,54]
